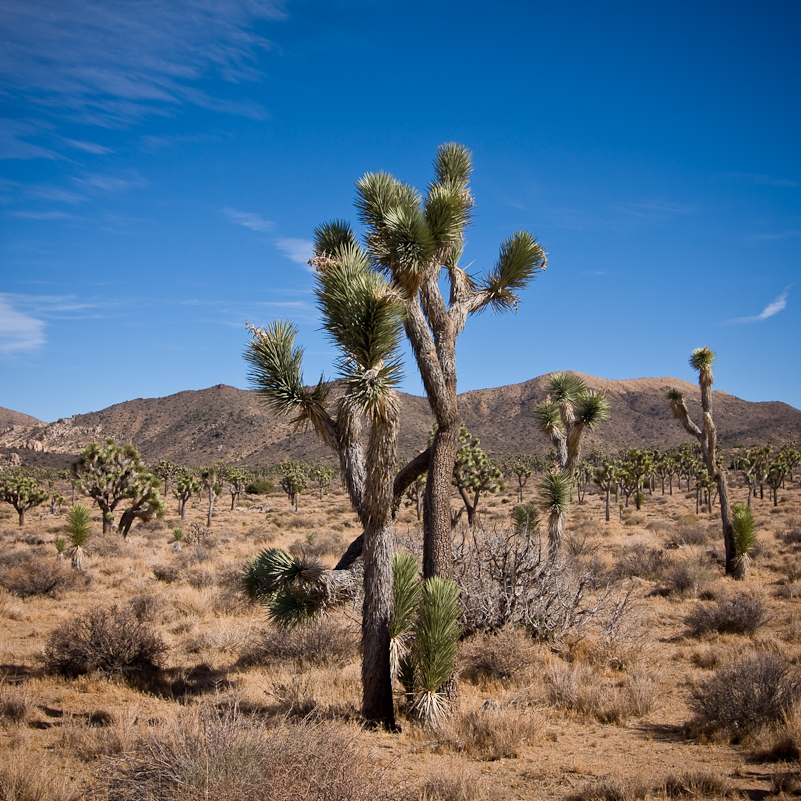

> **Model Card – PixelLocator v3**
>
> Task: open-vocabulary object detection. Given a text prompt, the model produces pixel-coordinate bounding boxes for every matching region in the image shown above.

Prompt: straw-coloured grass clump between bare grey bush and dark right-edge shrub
[545,662,656,724]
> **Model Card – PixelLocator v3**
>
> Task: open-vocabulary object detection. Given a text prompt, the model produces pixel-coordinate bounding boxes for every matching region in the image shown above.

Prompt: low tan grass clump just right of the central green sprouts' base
[446,702,542,762]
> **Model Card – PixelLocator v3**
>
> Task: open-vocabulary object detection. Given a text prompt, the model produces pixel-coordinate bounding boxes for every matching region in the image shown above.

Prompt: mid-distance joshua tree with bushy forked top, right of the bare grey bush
[532,373,609,558]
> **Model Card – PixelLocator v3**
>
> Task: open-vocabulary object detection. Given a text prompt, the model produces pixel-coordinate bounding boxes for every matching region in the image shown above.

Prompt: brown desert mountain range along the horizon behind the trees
[0,373,801,465]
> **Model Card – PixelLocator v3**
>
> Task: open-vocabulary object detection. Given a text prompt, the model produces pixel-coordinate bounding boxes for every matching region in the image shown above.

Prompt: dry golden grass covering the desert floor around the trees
[0,472,801,801]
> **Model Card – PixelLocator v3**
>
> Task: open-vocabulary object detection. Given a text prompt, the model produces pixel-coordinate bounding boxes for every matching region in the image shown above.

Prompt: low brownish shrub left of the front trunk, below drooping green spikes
[239,617,359,667]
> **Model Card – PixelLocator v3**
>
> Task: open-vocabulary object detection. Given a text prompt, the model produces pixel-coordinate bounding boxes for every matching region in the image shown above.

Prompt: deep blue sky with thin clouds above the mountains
[0,0,801,421]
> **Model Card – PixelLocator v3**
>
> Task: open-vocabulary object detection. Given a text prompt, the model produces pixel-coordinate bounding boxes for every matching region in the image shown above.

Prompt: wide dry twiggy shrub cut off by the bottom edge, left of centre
[97,705,411,801]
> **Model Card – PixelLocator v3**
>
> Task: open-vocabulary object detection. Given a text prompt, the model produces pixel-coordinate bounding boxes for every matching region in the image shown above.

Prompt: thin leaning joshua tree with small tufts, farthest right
[667,348,747,579]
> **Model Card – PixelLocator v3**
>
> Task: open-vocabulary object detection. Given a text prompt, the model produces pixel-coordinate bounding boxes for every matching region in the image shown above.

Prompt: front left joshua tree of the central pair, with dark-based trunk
[245,239,403,730]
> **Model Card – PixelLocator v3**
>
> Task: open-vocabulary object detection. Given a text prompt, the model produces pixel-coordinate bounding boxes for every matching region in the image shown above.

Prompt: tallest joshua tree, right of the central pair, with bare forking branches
[313,143,546,577]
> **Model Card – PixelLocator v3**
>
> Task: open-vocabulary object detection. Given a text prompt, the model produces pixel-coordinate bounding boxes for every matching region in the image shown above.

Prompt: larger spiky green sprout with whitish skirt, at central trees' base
[413,576,461,725]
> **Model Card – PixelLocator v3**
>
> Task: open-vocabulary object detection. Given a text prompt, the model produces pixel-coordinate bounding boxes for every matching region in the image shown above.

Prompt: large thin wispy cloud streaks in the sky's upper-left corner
[0,0,284,127]
